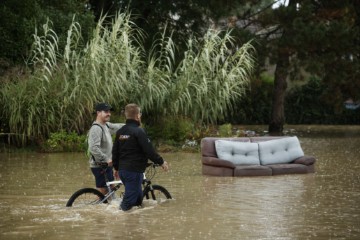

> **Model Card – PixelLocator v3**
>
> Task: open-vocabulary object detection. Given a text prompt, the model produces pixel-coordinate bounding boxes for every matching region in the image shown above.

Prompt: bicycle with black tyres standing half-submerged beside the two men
[66,163,172,207]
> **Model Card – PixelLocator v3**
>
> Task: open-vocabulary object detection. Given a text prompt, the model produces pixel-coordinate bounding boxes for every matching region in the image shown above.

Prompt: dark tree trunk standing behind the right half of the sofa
[269,49,289,135]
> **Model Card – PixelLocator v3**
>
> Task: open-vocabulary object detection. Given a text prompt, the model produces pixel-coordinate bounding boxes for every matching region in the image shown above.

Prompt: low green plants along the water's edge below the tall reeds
[0,122,262,153]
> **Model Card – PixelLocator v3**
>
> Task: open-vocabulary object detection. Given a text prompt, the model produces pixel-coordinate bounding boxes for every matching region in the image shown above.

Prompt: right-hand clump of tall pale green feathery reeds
[169,30,254,122]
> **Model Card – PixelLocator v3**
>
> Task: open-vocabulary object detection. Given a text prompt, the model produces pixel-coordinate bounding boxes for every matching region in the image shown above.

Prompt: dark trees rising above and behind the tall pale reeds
[0,0,360,141]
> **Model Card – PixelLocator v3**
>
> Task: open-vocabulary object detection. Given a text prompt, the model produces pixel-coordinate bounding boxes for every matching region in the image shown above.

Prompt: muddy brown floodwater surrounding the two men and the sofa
[0,126,360,239]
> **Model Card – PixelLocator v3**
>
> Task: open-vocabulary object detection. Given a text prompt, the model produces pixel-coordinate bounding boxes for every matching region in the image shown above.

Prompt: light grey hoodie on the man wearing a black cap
[88,122,125,168]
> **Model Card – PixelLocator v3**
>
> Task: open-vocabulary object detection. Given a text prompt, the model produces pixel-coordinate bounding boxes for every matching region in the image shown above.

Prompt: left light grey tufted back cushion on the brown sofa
[215,140,260,165]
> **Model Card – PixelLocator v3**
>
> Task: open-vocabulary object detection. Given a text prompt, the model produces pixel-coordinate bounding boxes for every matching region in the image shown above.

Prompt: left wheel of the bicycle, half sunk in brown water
[66,188,107,207]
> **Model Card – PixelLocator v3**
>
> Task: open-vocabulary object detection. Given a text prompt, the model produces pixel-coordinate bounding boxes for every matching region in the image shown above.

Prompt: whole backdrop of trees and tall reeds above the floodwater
[0,0,360,148]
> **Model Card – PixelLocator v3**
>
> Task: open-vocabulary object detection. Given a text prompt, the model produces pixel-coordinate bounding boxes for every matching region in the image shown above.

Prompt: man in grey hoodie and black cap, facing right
[88,103,125,194]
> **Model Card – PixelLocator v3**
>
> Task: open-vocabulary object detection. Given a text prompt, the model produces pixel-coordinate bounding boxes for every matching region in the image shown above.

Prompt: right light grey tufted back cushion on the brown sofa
[258,137,304,165]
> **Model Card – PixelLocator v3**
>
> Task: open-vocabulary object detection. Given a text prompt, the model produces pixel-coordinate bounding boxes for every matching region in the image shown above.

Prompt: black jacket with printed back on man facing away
[112,119,164,172]
